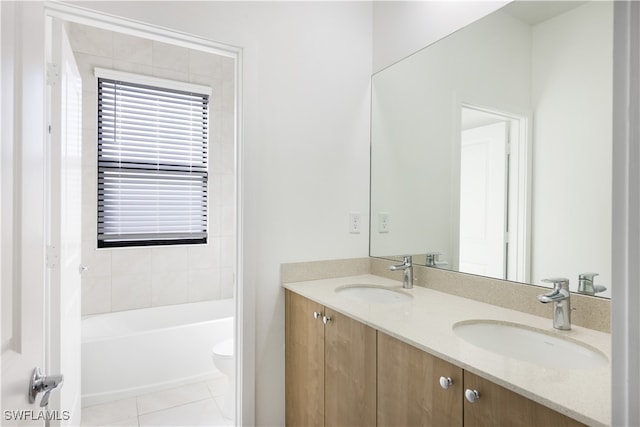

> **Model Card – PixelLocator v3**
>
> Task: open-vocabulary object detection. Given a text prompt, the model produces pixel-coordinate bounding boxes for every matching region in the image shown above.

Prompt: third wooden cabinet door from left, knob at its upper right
[378,332,463,427]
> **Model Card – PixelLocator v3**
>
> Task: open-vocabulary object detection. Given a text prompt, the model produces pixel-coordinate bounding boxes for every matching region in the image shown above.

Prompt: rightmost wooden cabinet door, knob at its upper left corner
[464,371,584,427]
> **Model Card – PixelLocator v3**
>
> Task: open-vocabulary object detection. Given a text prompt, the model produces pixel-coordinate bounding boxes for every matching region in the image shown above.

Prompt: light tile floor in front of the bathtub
[81,376,234,427]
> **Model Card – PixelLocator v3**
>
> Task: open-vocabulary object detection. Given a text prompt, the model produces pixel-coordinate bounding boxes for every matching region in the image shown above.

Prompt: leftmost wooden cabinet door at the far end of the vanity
[285,291,324,426]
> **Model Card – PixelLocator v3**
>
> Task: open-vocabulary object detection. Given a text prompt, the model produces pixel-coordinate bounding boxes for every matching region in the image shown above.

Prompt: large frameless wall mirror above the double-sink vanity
[370,1,613,296]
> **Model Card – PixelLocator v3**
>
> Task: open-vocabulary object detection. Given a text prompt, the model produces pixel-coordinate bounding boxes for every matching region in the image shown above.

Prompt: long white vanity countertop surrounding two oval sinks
[283,275,611,426]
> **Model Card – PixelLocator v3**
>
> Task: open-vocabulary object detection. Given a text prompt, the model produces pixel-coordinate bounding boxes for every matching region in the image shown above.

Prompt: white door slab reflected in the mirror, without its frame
[459,122,508,278]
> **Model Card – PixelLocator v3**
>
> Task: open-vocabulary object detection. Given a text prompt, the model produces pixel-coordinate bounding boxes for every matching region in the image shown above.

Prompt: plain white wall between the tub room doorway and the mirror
[64,1,371,425]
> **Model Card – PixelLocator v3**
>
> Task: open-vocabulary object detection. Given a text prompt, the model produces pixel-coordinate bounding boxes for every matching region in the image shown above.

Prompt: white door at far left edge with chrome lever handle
[0,2,47,426]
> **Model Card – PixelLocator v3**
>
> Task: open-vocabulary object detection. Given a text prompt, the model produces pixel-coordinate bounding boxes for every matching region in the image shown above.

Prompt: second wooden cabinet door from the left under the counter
[324,309,376,427]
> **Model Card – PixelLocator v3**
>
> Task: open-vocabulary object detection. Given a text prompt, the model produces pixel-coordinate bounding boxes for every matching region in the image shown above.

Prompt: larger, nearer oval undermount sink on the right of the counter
[453,320,609,369]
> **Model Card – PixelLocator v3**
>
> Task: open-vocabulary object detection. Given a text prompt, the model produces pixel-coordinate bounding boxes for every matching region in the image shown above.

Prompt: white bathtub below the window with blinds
[82,299,234,406]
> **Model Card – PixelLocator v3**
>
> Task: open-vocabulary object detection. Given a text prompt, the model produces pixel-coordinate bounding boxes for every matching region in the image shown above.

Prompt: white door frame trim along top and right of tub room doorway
[44,1,249,425]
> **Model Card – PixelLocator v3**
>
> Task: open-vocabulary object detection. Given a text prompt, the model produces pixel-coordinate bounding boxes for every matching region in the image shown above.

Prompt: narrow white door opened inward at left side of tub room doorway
[46,19,82,426]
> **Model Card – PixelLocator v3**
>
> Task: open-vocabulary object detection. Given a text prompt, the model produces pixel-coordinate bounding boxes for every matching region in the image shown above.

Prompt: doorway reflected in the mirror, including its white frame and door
[458,104,530,281]
